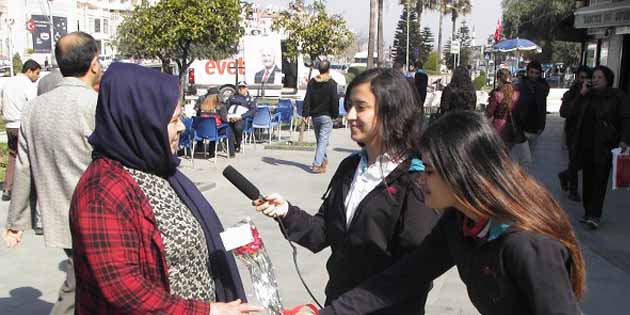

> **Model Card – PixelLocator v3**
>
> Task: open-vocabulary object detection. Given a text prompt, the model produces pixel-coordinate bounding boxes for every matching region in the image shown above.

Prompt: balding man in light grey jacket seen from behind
[4,32,102,315]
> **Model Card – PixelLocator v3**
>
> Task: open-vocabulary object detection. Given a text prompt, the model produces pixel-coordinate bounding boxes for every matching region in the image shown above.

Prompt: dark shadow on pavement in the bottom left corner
[0,287,53,315]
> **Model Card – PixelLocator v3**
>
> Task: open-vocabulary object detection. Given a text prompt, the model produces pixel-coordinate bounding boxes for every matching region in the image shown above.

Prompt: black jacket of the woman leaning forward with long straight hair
[320,210,581,315]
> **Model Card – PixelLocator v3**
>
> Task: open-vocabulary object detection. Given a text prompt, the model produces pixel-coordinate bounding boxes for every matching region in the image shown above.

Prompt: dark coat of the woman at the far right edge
[570,88,630,164]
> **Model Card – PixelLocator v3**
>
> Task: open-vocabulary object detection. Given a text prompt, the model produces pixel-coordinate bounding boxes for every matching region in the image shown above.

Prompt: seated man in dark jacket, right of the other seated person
[227,81,256,152]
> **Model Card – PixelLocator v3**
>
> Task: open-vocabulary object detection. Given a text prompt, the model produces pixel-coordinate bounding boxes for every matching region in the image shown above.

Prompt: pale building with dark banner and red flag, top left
[0,0,142,65]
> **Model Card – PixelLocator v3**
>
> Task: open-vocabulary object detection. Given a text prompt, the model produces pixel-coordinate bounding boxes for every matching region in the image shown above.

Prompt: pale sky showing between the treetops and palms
[252,0,502,47]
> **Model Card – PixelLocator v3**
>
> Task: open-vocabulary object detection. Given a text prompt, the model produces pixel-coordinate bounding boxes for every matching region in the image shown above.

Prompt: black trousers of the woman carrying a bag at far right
[582,154,612,218]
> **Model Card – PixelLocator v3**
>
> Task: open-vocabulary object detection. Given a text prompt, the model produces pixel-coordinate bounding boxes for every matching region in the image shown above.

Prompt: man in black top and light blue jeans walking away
[302,60,339,174]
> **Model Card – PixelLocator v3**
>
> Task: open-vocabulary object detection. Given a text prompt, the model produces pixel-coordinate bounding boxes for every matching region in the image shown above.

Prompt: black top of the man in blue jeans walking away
[302,74,339,119]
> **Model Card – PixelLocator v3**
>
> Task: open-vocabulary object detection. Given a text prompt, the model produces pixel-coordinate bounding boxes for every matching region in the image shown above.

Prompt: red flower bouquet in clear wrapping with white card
[233,218,283,315]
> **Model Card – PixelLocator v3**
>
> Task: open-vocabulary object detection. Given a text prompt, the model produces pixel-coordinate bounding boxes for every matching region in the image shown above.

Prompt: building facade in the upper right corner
[574,0,630,93]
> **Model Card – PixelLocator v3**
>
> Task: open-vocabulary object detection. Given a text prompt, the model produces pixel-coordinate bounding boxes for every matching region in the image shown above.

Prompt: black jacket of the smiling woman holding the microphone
[282,154,438,315]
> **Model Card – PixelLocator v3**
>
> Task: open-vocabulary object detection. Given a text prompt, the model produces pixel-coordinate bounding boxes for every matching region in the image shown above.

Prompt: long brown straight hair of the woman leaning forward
[419,111,585,298]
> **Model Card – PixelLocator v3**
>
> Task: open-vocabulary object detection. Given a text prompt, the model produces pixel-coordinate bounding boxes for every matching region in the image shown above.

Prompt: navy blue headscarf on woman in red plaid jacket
[89,63,246,302]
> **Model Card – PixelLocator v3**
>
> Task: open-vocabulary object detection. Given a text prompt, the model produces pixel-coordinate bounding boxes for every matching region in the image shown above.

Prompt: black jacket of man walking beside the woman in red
[514,78,549,133]
